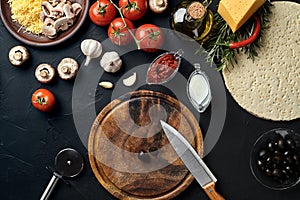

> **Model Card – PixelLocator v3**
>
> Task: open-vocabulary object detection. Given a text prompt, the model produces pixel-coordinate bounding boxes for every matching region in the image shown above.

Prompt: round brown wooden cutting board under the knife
[88,90,203,200]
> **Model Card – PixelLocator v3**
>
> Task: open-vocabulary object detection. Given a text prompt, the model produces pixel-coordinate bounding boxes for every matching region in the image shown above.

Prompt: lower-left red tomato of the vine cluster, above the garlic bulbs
[108,17,134,46]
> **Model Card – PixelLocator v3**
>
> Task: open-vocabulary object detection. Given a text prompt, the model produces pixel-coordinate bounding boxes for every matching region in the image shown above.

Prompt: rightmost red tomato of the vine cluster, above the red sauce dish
[135,24,164,52]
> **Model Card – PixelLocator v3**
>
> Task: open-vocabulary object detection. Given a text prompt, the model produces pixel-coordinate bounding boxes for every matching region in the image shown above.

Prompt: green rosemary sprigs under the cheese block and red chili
[202,0,273,70]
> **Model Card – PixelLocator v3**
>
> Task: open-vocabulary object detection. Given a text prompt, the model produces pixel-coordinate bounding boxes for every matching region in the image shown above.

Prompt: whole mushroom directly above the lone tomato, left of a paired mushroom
[35,63,55,83]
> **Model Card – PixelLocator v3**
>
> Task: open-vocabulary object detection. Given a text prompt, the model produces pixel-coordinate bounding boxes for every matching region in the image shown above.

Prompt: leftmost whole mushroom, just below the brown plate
[8,46,29,66]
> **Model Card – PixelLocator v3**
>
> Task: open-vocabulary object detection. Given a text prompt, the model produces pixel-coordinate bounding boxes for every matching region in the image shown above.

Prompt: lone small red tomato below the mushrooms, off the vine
[31,89,55,112]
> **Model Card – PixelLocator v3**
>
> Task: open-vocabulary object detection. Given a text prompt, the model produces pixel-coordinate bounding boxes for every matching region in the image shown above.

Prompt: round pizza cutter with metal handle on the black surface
[40,148,84,200]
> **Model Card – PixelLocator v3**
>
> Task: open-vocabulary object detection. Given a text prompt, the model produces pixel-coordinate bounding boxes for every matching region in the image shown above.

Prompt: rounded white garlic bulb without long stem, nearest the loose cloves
[100,51,122,73]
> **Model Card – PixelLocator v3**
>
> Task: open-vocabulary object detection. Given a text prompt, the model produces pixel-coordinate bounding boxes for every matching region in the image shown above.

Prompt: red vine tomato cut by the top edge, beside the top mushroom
[119,0,148,20]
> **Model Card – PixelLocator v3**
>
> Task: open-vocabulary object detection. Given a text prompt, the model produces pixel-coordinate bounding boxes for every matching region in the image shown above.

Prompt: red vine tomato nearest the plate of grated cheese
[89,0,117,26]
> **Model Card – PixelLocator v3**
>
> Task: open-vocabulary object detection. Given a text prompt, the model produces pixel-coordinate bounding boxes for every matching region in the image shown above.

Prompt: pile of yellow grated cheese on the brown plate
[8,0,43,34]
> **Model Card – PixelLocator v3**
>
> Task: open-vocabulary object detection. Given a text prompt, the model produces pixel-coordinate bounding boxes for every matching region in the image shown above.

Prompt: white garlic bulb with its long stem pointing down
[80,39,102,66]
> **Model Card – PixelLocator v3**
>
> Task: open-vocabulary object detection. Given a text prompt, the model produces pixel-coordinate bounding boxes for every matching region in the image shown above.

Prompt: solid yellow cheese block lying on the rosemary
[218,0,265,32]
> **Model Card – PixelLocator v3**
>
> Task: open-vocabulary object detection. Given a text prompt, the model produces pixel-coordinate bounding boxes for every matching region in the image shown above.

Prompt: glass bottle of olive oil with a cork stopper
[170,0,213,43]
